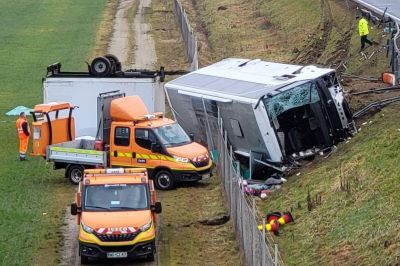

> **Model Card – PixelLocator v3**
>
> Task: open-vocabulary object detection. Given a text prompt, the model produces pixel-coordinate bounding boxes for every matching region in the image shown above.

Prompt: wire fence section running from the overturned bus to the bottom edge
[217,115,283,266]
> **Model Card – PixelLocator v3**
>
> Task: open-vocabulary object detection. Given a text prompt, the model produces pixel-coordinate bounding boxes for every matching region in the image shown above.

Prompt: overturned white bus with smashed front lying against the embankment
[165,58,356,178]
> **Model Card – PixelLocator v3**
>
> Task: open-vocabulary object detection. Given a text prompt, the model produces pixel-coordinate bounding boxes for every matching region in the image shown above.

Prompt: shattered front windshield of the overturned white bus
[264,81,331,155]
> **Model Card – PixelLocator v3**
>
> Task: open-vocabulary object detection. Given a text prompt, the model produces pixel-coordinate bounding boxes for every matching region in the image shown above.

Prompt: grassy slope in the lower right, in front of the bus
[261,104,400,265]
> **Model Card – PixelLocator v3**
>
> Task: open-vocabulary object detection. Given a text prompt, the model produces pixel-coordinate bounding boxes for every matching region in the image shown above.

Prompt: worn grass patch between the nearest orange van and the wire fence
[158,176,241,266]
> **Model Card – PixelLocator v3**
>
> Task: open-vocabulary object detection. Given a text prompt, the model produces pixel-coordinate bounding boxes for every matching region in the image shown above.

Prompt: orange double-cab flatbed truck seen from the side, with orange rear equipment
[32,92,212,190]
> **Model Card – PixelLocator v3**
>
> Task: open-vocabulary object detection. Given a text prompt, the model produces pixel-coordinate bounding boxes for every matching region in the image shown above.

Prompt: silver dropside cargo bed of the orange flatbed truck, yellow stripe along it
[46,139,107,167]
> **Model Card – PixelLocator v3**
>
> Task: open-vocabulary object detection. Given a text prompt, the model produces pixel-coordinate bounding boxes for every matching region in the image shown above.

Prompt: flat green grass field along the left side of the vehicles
[0,0,106,265]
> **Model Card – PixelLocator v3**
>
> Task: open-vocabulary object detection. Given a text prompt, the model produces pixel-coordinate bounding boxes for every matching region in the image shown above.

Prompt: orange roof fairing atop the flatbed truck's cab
[110,96,149,121]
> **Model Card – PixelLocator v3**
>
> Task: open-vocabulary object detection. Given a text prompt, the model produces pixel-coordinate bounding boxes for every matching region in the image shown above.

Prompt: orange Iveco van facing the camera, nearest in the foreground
[71,168,161,264]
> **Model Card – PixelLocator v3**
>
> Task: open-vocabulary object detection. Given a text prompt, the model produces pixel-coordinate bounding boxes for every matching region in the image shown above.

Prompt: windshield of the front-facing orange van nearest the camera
[84,184,149,211]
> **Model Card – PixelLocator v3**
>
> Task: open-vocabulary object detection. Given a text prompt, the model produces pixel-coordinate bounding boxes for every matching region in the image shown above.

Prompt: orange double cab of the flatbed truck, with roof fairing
[103,93,212,190]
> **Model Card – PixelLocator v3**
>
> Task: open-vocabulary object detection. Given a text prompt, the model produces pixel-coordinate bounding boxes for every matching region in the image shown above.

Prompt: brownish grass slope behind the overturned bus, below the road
[182,0,388,77]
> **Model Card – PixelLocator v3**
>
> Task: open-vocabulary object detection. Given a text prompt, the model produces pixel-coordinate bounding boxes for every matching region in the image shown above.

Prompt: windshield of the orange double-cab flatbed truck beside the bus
[154,123,191,147]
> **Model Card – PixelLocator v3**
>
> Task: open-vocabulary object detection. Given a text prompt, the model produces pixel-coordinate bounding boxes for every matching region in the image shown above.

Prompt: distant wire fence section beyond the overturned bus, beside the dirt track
[174,0,199,71]
